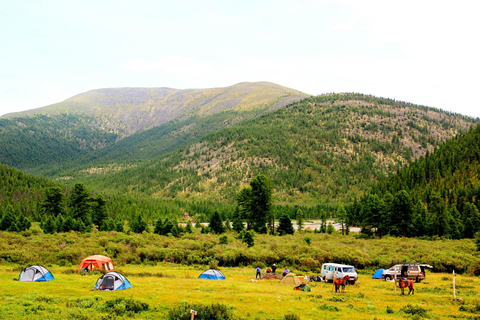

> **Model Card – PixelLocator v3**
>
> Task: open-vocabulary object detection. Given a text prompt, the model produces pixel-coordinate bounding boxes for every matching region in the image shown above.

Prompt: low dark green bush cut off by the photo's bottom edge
[167,303,235,320]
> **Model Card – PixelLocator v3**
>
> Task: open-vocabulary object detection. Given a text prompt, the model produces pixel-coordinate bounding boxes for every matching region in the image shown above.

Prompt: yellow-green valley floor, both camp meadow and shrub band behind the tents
[0,232,480,320]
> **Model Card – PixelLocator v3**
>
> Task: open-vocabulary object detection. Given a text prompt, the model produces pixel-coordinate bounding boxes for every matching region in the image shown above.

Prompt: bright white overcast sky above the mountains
[0,0,480,117]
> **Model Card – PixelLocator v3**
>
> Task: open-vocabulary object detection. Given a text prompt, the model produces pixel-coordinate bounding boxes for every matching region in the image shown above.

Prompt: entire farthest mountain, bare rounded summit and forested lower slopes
[0,82,308,176]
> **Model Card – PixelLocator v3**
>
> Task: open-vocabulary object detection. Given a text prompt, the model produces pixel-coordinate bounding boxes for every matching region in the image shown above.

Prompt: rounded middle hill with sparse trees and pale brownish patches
[75,94,475,205]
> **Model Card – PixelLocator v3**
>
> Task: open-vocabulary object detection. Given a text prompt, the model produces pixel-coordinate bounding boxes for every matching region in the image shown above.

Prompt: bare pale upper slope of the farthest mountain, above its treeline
[3,82,308,135]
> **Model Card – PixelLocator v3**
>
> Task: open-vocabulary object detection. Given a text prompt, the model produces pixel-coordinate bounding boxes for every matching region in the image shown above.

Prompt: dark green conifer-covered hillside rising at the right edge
[349,125,480,239]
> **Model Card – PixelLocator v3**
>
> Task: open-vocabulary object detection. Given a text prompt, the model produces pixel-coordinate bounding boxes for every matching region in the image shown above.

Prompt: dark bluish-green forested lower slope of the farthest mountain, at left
[0,114,119,171]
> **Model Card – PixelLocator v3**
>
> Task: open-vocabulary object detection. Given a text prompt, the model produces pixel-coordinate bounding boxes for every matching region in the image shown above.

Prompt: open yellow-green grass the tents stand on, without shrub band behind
[0,263,480,320]
